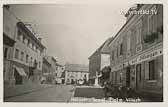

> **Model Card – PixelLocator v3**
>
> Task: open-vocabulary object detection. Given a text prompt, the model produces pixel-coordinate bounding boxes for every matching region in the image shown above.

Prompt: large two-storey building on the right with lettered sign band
[109,4,163,95]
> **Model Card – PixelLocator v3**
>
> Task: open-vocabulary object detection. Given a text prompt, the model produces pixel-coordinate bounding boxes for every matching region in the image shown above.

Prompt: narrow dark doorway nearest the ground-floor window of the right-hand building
[136,64,141,90]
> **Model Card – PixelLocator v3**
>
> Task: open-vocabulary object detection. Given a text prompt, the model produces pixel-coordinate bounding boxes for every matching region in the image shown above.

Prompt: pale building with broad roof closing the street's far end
[65,64,89,84]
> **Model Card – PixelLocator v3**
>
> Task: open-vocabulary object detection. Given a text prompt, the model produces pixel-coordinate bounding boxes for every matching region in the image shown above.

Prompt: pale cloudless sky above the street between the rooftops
[10,3,132,64]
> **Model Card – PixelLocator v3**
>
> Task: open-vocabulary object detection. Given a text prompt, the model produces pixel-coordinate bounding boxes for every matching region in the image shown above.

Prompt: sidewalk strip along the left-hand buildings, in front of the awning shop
[4,83,53,100]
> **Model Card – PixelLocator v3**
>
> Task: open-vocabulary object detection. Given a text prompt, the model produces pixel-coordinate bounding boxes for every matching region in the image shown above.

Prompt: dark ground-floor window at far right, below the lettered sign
[149,60,155,80]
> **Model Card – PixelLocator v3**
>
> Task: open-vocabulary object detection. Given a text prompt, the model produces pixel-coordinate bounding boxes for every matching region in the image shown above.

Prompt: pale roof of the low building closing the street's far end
[65,64,89,72]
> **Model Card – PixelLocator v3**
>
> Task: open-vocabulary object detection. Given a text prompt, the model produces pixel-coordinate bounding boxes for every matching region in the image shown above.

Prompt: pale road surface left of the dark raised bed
[5,85,74,102]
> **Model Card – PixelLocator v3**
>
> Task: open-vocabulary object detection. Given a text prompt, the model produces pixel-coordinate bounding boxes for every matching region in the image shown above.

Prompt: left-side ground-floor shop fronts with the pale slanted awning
[4,60,41,86]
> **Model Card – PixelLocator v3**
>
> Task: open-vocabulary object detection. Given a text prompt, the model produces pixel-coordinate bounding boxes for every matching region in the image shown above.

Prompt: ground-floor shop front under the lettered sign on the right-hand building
[110,48,163,95]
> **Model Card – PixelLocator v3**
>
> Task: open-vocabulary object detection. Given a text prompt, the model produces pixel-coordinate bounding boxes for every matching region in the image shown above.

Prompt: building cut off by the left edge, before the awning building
[3,5,17,85]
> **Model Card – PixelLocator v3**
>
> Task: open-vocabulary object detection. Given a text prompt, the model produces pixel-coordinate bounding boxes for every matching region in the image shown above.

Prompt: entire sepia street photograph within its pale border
[2,2,164,103]
